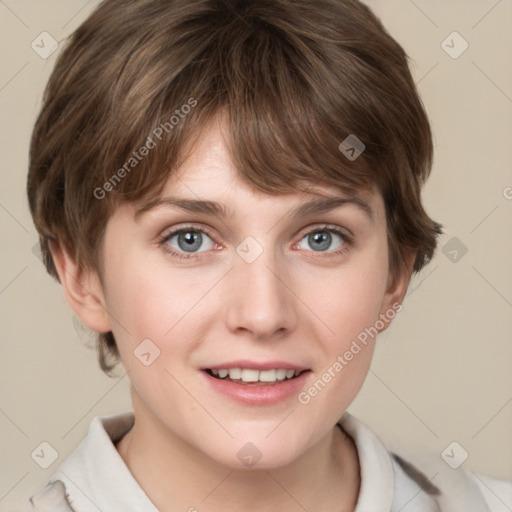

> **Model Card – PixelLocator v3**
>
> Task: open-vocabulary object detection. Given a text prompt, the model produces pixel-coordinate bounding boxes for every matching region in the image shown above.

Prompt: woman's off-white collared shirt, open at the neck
[20,411,512,512]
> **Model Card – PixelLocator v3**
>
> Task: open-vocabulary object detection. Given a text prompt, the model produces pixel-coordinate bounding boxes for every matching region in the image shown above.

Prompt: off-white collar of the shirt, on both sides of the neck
[50,411,466,512]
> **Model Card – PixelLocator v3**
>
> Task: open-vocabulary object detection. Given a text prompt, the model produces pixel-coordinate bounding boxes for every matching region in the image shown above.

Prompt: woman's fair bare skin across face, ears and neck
[53,116,412,512]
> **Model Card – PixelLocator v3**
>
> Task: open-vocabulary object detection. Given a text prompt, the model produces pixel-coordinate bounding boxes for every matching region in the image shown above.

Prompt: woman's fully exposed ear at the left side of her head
[50,243,112,332]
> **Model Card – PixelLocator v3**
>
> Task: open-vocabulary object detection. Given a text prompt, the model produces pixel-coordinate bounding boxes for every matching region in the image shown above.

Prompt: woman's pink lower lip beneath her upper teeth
[201,370,310,405]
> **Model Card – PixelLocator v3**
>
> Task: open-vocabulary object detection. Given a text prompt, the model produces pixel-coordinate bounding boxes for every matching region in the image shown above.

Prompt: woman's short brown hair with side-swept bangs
[27,0,442,374]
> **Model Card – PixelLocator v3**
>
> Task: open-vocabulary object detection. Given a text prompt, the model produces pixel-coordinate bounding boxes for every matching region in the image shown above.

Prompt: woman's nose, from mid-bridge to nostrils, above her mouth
[224,244,298,340]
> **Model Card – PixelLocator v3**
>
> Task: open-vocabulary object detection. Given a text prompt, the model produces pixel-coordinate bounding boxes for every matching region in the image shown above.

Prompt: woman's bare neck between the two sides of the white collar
[117,404,360,512]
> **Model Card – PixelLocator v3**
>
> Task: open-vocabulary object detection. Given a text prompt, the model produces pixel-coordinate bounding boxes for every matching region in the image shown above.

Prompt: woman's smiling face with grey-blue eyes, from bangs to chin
[92,115,404,468]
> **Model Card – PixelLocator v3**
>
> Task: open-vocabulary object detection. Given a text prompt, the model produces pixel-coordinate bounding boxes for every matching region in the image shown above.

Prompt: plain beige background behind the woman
[0,0,512,510]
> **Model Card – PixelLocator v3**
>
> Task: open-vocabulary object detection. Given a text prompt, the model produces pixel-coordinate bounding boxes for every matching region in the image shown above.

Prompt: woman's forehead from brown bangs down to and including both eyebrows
[127,114,385,226]
